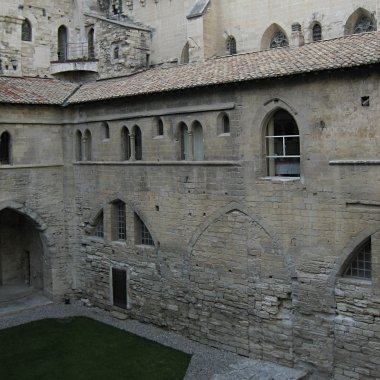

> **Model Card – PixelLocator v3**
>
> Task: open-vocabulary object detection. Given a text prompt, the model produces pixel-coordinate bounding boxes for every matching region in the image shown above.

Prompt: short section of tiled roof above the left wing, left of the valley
[0,77,79,104]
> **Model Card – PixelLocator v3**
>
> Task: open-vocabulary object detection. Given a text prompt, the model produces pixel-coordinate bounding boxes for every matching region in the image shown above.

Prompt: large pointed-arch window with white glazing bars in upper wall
[265,110,300,177]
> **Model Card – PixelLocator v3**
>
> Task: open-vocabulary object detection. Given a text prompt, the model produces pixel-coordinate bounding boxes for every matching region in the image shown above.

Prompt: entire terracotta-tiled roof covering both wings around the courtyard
[0,32,380,105]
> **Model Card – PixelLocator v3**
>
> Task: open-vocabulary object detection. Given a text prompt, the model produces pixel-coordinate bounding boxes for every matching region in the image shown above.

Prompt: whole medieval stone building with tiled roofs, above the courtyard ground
[0,0,380,379]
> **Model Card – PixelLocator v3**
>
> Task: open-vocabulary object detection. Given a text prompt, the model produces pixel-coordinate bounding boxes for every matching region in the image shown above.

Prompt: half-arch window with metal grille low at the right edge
[343,237,372,279]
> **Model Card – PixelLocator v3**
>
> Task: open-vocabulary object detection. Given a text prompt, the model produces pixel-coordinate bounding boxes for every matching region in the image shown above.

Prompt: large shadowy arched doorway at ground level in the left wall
[0,208,44,290]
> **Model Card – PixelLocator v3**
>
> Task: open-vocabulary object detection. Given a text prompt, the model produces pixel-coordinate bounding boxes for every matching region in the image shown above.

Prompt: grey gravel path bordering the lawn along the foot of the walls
[0,304,305,380]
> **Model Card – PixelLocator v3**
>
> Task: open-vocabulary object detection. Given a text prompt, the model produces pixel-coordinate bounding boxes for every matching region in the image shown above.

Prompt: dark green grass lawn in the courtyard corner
[0,317,191,380]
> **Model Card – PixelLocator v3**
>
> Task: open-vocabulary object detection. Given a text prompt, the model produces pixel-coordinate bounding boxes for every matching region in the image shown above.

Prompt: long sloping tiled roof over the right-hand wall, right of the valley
[68,32,380,103]
